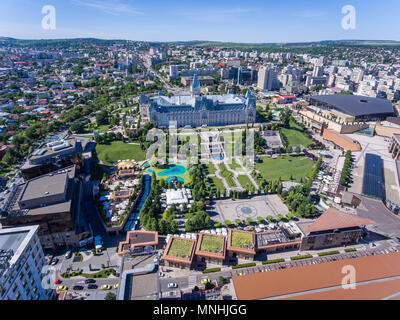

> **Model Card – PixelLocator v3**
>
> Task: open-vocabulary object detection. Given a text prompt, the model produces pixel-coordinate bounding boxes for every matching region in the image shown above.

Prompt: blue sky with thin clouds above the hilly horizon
[0,0,400,43]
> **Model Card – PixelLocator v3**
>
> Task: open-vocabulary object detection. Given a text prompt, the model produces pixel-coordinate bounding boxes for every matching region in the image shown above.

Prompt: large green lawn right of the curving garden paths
[255,156,314,182]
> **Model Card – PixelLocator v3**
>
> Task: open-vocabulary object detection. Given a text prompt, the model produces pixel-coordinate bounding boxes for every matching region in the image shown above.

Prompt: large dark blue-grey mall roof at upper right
[310,94,394,116]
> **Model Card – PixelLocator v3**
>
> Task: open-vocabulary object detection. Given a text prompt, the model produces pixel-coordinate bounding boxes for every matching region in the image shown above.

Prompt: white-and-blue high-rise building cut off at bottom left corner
[0,225,55,300]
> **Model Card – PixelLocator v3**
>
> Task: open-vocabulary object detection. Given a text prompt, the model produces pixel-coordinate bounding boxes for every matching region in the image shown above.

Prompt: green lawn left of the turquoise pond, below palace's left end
[96,141,145,166]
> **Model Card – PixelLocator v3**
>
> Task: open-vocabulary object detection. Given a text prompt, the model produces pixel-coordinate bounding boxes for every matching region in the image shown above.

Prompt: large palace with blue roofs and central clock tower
[140,76,256,128]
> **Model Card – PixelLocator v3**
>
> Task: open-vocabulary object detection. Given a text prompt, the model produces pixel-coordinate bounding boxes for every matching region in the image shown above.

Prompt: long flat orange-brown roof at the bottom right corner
[232,252,400,300]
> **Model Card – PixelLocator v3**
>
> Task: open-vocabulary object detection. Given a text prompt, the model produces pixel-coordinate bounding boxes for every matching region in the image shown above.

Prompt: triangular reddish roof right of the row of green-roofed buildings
[306,208,375,234]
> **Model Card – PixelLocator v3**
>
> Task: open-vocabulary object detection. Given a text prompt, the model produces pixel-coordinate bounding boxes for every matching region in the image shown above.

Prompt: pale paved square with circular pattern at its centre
[211,195,289,222]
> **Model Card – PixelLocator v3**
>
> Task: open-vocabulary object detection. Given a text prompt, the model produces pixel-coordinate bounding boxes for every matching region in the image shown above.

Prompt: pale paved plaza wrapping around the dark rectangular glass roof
[347,134,400,203]
